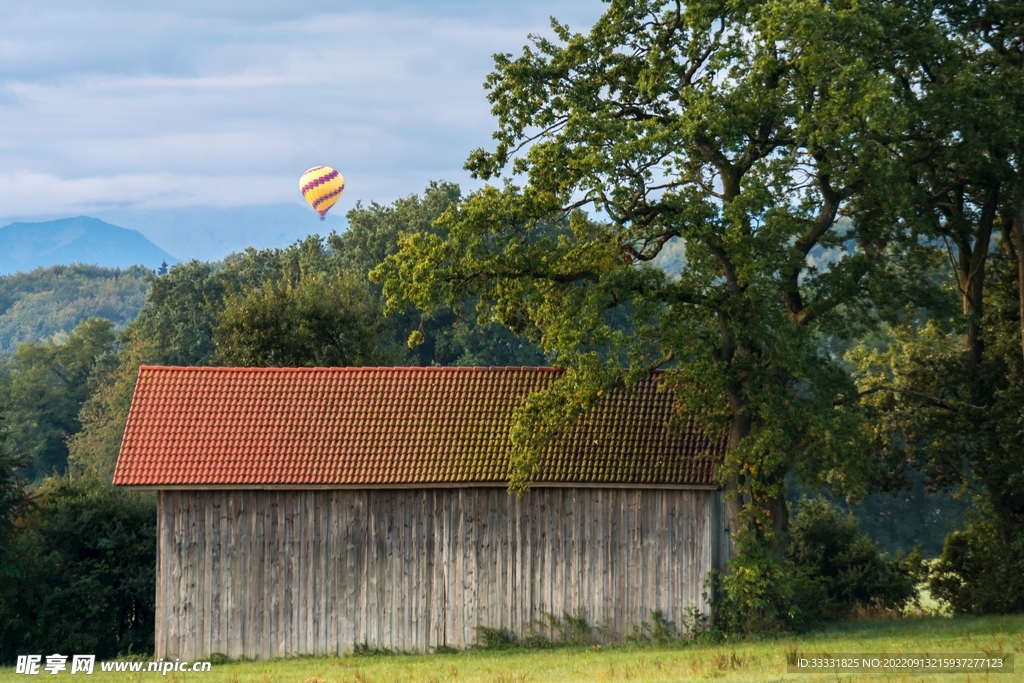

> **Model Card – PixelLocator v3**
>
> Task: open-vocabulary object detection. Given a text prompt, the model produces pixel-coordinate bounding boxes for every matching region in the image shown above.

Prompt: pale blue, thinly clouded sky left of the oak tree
[0,0,603,224]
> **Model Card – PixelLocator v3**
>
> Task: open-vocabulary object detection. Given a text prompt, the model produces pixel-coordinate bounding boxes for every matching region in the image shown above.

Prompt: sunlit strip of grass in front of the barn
[0,615,1024,683]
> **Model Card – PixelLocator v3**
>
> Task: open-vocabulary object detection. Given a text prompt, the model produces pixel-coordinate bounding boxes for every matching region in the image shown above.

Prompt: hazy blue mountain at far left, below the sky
[0,216,178,274]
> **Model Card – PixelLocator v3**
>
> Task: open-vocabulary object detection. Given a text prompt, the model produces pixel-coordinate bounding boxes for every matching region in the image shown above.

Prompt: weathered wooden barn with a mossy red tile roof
[114,367,728,659]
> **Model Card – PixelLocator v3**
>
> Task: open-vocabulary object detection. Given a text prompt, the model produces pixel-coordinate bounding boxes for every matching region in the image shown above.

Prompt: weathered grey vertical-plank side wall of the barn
[156,488,727,659]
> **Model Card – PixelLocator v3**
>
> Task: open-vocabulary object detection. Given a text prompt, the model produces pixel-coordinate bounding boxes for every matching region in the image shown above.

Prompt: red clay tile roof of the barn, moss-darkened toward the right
[114,367,723,487]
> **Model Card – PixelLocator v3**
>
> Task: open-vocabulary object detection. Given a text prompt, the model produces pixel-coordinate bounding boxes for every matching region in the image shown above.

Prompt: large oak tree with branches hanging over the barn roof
[376,0,929,614]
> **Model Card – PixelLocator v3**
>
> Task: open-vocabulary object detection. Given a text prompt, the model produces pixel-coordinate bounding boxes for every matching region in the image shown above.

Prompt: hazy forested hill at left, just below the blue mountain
[0,264,153,351]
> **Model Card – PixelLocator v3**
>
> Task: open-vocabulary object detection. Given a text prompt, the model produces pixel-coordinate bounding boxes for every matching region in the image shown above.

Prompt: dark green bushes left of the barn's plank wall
[0,477,156,663]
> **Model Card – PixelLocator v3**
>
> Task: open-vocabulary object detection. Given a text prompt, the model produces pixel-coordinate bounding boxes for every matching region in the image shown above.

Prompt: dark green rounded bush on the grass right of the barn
[786,498,915,625]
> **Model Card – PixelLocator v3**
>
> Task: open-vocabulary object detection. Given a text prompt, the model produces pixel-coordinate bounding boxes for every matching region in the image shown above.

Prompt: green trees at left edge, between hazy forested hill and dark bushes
[0,317,115,480]
